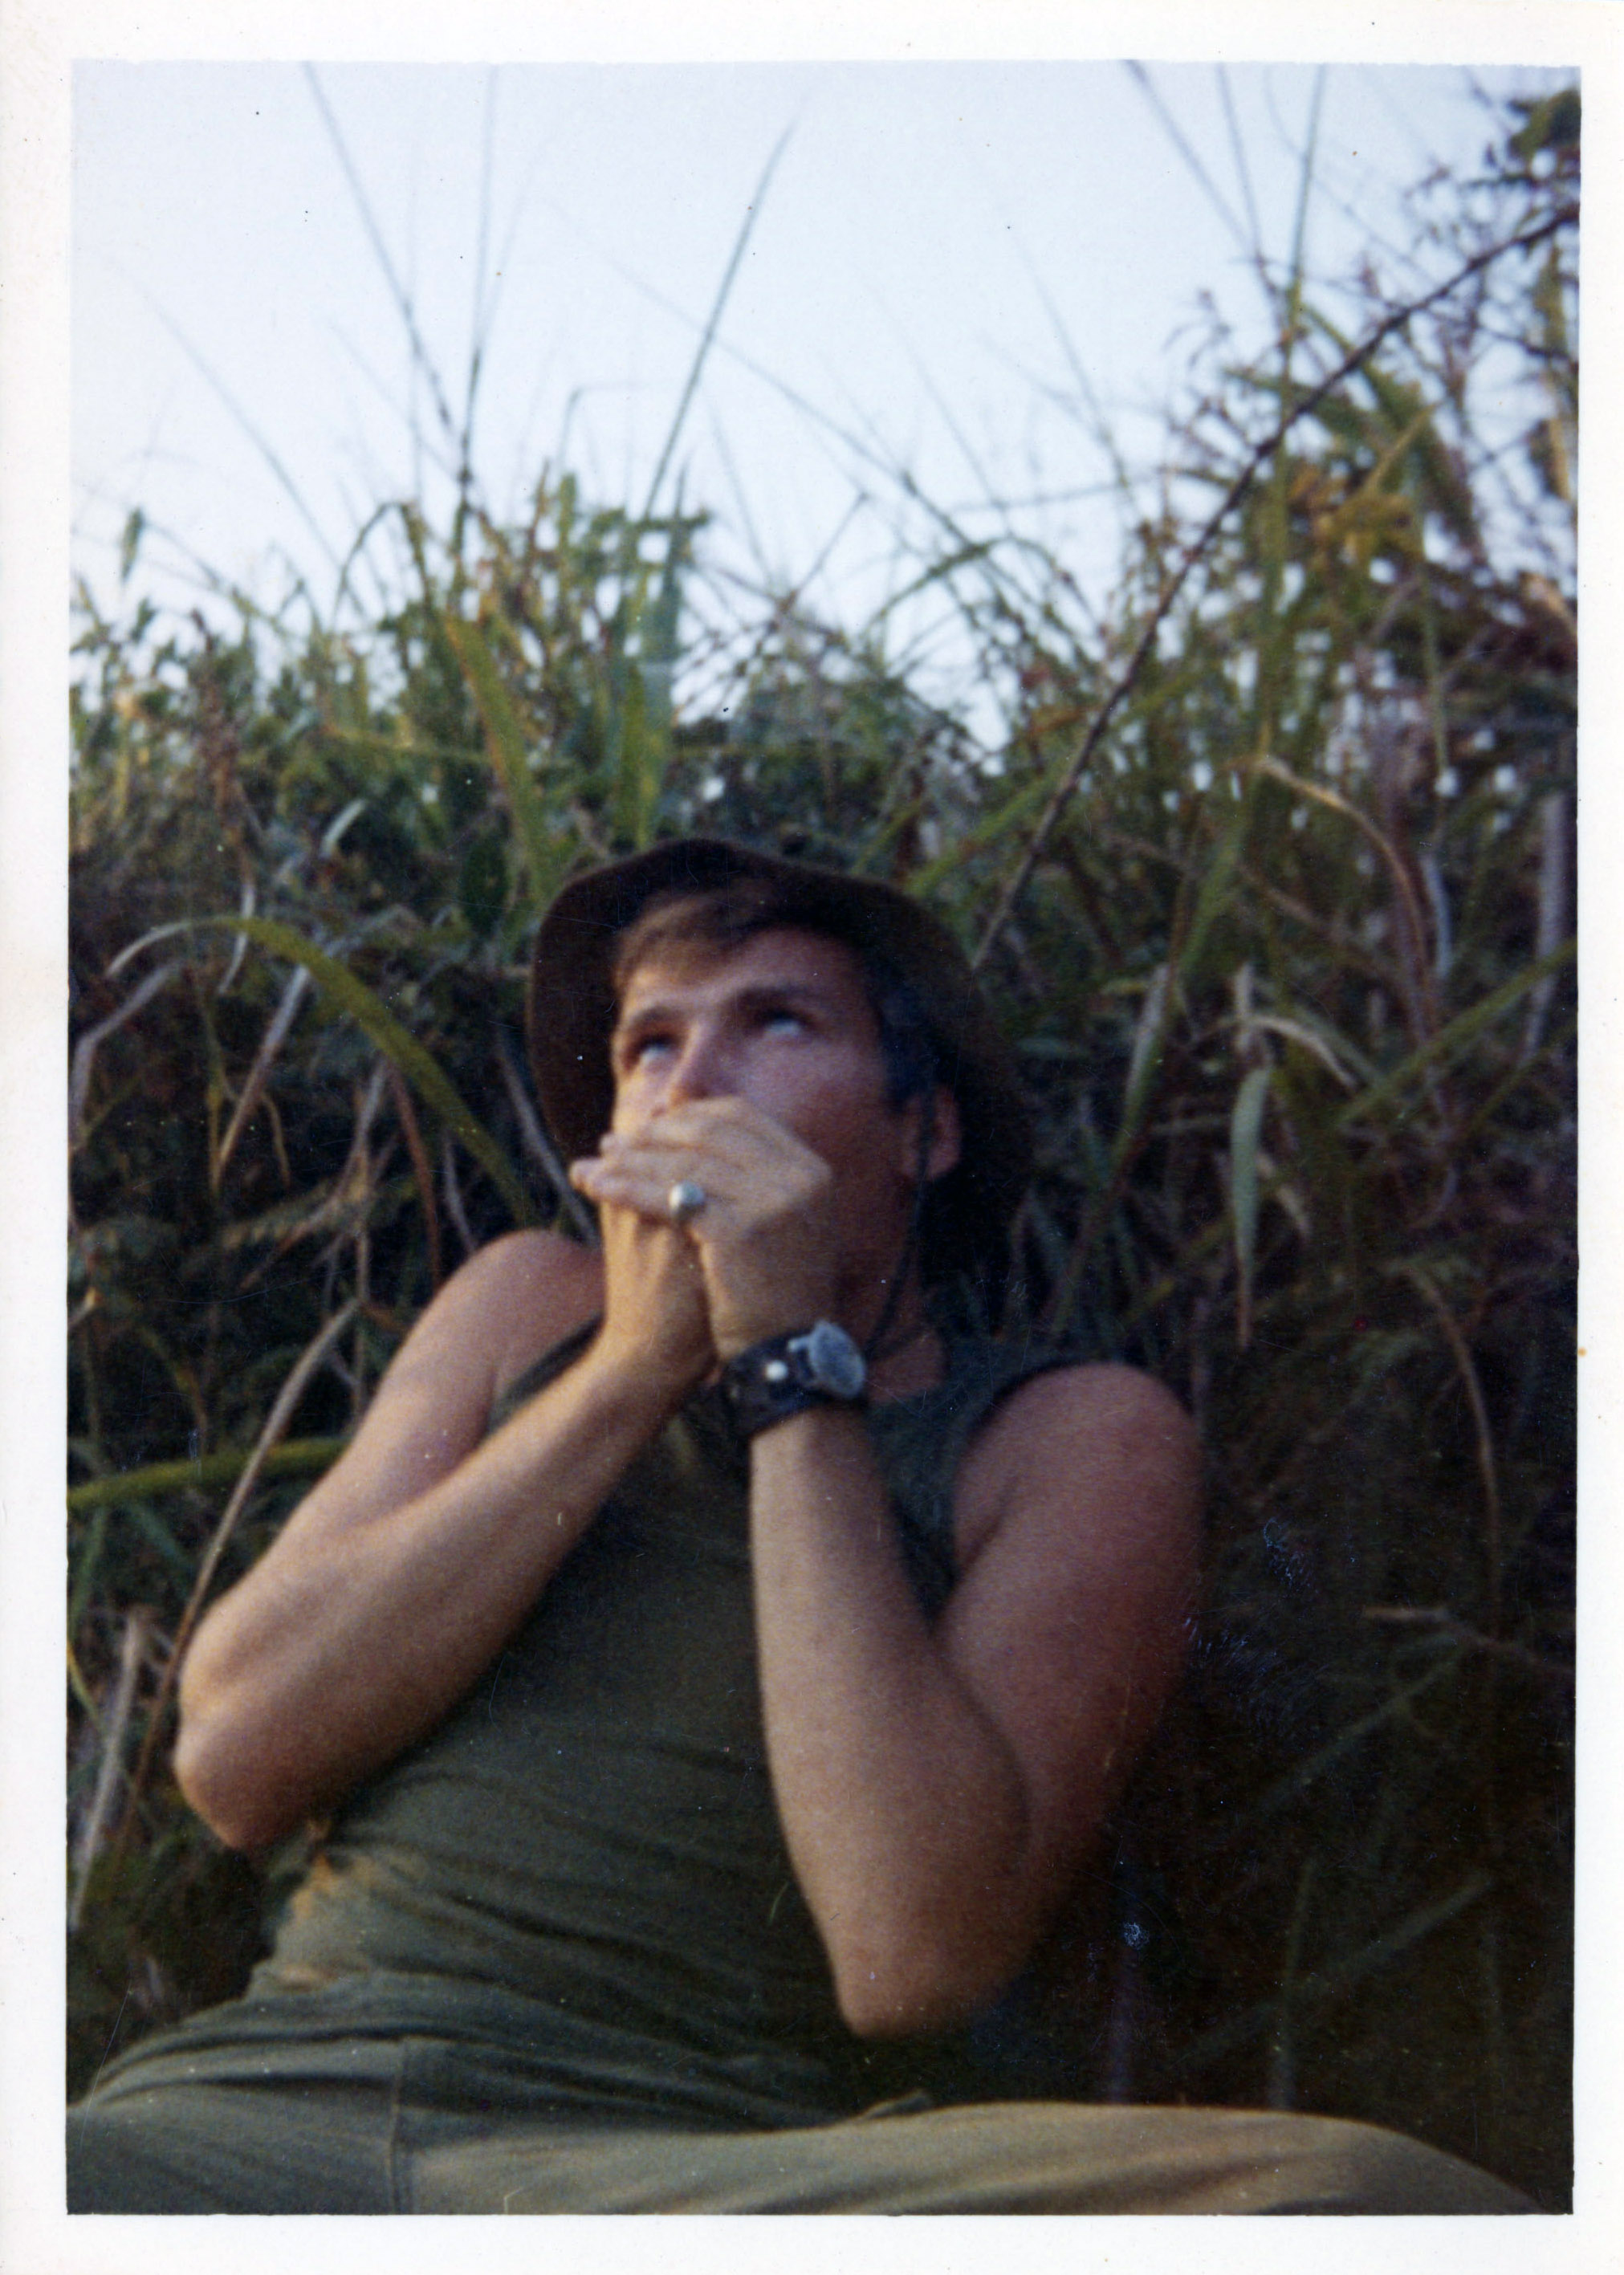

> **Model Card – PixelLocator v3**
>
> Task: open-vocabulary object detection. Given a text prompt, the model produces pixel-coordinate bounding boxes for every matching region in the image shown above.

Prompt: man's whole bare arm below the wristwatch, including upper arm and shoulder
[753,1367,1196,2036]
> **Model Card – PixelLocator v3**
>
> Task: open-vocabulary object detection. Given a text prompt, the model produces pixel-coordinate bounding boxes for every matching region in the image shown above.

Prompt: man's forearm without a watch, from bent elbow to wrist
[175,1351,680,1847]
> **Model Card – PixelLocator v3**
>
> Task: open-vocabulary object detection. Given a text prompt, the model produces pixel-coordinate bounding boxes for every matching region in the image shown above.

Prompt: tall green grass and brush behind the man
[68,91,1578,2209]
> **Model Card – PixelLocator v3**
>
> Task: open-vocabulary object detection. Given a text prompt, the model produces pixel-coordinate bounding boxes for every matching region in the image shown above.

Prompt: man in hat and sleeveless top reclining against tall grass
[71,840,1526,2212]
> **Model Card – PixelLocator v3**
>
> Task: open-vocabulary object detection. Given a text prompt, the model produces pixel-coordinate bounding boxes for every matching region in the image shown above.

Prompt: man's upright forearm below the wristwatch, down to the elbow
[751,1408,1044,2034]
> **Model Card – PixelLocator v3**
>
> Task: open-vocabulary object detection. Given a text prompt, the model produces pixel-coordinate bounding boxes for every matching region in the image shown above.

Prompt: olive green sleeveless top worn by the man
[238,1331,1076,2125]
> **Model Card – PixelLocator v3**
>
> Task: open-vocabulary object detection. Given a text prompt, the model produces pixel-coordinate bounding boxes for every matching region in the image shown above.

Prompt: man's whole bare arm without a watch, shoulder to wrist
[175,1231,710,1847]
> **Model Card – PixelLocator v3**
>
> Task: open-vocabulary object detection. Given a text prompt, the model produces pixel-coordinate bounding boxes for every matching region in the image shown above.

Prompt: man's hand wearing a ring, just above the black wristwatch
[571,1099,837,1361]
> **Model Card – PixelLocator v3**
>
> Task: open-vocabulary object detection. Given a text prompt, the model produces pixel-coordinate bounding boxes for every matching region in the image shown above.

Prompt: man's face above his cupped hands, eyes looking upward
[609,928,937,1260]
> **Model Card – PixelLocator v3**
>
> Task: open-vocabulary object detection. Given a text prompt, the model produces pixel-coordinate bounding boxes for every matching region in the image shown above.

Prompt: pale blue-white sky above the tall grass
[73,62,1563,718]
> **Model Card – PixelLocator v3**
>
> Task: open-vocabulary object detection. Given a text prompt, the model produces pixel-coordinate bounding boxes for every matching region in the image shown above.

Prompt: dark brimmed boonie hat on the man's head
[526,837,1031,1279]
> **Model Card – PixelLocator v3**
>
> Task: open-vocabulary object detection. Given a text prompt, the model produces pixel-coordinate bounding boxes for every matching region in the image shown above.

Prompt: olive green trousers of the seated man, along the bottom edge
[68,2041,1536,2213]
